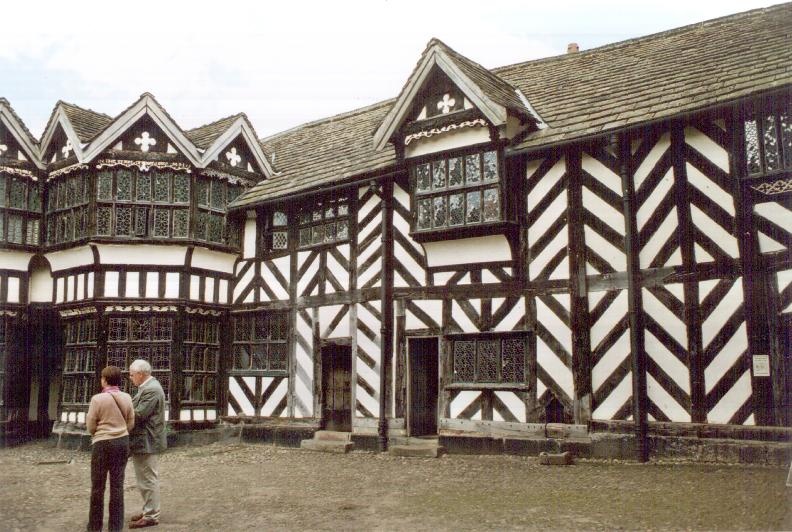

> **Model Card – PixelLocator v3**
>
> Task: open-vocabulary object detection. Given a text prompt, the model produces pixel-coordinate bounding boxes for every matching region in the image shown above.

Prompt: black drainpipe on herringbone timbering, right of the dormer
[616,134,649,462]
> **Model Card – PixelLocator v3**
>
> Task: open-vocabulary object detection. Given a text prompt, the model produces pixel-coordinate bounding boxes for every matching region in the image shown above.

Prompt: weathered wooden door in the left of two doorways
[322,345,352,432]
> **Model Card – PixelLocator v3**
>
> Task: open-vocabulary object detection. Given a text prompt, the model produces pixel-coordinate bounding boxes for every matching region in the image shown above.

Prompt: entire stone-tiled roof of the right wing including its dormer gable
[231,3,792,208]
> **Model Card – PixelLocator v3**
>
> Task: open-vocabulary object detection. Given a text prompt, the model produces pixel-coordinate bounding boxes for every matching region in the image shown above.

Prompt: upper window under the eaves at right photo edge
[743,105,792,176]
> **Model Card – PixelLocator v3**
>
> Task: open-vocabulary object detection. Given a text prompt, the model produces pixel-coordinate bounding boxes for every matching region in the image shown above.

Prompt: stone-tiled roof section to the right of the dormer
[502,3,792,149]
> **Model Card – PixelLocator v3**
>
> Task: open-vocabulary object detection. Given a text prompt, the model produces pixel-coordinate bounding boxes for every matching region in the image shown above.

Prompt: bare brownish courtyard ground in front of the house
[0,442,792,531]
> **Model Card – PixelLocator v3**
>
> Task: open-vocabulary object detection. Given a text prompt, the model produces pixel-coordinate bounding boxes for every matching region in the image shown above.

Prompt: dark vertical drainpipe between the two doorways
[377,178,393,452]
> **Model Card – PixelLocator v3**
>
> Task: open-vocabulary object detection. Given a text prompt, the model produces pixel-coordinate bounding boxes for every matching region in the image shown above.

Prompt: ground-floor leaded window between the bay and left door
[233,312,288,375]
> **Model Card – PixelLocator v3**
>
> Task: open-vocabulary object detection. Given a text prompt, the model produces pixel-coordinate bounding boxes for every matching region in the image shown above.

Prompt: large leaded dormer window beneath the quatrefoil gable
[412,151,503,232]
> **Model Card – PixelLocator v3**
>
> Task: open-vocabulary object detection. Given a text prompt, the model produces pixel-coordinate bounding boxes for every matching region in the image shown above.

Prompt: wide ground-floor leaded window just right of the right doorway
[451,334,528,384]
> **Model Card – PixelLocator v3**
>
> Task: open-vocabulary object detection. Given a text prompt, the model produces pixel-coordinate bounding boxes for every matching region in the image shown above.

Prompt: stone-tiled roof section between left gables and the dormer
[233,100,396,207]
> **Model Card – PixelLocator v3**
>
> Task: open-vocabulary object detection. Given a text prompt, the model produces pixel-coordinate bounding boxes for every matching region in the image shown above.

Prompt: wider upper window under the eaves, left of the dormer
[298,196,349,248]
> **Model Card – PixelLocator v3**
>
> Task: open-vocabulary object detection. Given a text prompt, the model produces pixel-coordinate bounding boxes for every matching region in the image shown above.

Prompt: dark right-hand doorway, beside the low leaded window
[408,338,439,436]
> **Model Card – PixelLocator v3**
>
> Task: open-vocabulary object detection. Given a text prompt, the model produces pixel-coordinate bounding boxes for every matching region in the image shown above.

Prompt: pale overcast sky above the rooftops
[0,0,778,137]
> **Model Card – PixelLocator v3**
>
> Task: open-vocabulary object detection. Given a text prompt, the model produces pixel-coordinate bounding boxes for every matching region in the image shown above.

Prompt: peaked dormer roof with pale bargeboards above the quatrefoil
[374,39,533,150]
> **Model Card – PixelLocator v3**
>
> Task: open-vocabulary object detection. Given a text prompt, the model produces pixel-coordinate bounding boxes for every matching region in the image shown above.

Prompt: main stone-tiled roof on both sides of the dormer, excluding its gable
[212,3,792,206]
